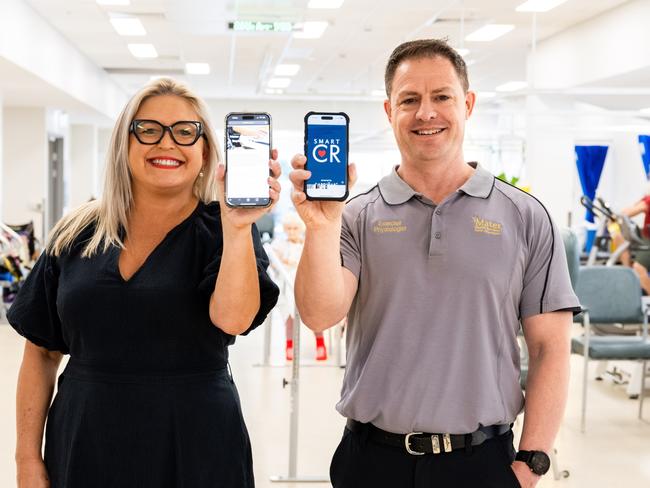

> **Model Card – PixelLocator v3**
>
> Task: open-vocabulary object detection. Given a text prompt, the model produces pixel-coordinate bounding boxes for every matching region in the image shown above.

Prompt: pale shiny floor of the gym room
[0,310,650,488]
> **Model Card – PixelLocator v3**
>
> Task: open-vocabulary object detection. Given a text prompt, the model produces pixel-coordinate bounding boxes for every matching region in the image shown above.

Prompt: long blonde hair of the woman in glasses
[47,78,221,257]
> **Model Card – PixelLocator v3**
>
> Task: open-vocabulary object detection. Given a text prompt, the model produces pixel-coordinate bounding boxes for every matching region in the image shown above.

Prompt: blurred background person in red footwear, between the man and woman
[273,212,327,361]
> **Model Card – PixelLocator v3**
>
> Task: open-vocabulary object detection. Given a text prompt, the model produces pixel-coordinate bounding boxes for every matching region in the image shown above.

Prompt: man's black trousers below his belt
[330,428,520,488]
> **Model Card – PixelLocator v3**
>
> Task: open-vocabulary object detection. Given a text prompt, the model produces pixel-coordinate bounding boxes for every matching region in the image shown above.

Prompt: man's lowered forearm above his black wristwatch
[519,348,569,453]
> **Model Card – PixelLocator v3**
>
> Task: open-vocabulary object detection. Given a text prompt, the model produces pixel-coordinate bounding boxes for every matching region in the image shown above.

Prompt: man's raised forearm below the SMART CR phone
[295,222,347,331]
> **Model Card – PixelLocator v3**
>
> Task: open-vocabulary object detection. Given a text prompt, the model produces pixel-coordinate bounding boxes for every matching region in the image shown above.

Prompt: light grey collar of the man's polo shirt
[379,162,494,205]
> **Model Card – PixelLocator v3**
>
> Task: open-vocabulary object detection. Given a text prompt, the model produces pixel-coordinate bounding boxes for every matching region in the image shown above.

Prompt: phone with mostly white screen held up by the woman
[226,113,271,207]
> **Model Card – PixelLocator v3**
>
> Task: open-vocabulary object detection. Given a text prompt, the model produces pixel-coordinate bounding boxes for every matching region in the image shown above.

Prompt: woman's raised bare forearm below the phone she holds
[210,225,260,335]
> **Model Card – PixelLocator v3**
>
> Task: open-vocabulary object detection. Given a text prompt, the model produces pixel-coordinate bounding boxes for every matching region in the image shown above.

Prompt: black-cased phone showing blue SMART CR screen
[305,113,349,200]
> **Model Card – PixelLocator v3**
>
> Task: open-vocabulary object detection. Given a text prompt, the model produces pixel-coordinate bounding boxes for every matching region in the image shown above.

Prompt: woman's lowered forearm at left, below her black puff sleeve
[16,341,63,463]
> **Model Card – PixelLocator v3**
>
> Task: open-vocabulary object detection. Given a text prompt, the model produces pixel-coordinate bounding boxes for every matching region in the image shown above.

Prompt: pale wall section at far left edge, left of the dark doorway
[2,107,48,240]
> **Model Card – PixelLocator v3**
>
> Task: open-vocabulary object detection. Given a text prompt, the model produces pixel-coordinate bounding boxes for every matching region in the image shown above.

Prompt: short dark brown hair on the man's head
[384,39,469,98]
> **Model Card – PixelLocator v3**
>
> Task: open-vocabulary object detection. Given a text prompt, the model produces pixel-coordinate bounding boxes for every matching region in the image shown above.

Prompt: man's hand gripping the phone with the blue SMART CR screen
[289,154,357,229]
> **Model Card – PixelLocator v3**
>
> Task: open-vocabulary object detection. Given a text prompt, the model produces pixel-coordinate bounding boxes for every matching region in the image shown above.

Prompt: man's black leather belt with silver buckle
[346,419,511,456]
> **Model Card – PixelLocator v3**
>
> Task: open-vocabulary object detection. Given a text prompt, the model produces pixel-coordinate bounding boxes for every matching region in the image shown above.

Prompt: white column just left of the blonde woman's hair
[68,124,98,209]
